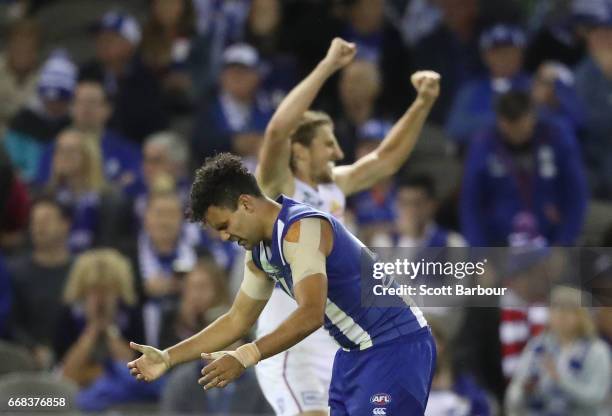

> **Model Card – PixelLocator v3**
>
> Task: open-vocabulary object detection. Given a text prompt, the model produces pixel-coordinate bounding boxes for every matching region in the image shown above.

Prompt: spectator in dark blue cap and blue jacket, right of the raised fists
[446,24,529,147]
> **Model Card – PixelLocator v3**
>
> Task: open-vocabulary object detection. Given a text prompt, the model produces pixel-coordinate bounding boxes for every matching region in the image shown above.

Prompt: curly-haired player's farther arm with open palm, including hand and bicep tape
[128,252,274,381]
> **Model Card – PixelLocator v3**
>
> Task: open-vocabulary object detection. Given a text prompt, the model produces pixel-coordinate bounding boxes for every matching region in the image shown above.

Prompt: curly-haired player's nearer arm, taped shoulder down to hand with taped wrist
[199,218,333,389]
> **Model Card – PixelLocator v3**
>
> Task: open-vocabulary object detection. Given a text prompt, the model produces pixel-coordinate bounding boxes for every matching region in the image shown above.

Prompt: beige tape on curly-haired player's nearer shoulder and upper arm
[283,218,327,285]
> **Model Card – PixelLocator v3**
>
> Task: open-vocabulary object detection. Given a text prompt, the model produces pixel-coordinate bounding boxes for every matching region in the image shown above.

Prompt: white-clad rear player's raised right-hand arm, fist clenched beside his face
[334,71,440,195]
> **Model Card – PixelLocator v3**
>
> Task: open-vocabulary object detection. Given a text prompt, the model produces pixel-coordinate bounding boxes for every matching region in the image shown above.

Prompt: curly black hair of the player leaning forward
[189,153,263,222]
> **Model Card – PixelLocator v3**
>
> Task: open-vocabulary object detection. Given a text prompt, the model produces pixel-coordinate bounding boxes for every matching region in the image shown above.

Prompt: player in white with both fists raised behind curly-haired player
[249,38,440,416]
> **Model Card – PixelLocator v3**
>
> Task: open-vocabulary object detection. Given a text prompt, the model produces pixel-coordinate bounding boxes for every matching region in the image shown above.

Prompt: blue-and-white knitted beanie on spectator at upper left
[38,49,77,101]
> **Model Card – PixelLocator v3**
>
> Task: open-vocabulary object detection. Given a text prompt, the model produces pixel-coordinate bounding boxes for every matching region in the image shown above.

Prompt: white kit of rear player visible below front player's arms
[255,289,338,416]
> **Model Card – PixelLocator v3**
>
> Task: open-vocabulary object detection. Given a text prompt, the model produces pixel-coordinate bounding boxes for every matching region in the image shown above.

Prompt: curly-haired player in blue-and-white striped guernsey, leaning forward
[128,153,435,416]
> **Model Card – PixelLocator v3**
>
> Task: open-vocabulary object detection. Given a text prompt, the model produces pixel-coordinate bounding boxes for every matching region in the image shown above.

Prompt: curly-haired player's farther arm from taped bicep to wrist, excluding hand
[168,252,274,365]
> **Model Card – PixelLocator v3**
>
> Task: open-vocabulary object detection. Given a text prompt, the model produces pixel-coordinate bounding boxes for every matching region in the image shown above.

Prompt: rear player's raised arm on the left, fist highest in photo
[256,38,356,198]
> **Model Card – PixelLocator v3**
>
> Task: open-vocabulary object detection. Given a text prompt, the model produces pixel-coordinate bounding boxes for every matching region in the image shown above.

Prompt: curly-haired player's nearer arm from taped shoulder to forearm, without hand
[255,218,333,359]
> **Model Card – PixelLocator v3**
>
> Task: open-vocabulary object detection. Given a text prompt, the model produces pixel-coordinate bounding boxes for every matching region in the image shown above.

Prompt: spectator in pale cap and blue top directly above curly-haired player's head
[192,43,271,167]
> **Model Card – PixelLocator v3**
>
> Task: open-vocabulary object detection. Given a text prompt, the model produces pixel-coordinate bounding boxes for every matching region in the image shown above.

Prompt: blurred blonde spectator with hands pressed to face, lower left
[56,249,143,386]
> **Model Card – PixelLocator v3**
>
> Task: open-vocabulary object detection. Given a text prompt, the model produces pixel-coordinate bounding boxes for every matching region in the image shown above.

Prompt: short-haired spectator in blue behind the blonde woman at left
[37,80,142,188]
